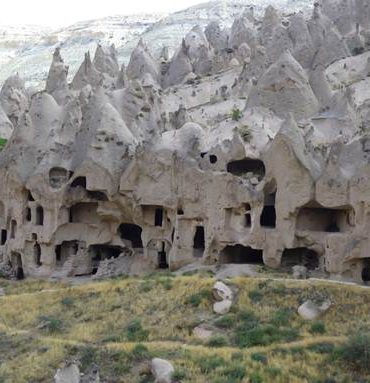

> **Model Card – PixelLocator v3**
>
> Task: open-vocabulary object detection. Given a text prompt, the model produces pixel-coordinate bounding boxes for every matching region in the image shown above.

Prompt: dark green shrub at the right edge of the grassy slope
[335,332,370,373]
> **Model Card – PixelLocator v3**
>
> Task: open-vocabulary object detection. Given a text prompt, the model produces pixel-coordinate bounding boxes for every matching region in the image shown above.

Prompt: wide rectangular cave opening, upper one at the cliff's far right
[297,204,351,233]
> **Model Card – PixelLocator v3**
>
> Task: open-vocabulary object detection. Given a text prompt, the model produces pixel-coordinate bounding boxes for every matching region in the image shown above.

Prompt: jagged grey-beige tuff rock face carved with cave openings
[0,0,370,283]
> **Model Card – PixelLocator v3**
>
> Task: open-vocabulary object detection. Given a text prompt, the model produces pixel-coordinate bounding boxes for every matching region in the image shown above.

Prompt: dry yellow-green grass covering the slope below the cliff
[0,275,370,383]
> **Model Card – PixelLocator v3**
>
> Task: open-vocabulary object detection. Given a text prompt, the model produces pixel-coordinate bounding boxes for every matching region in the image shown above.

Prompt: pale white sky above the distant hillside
[0,0,206,27]
